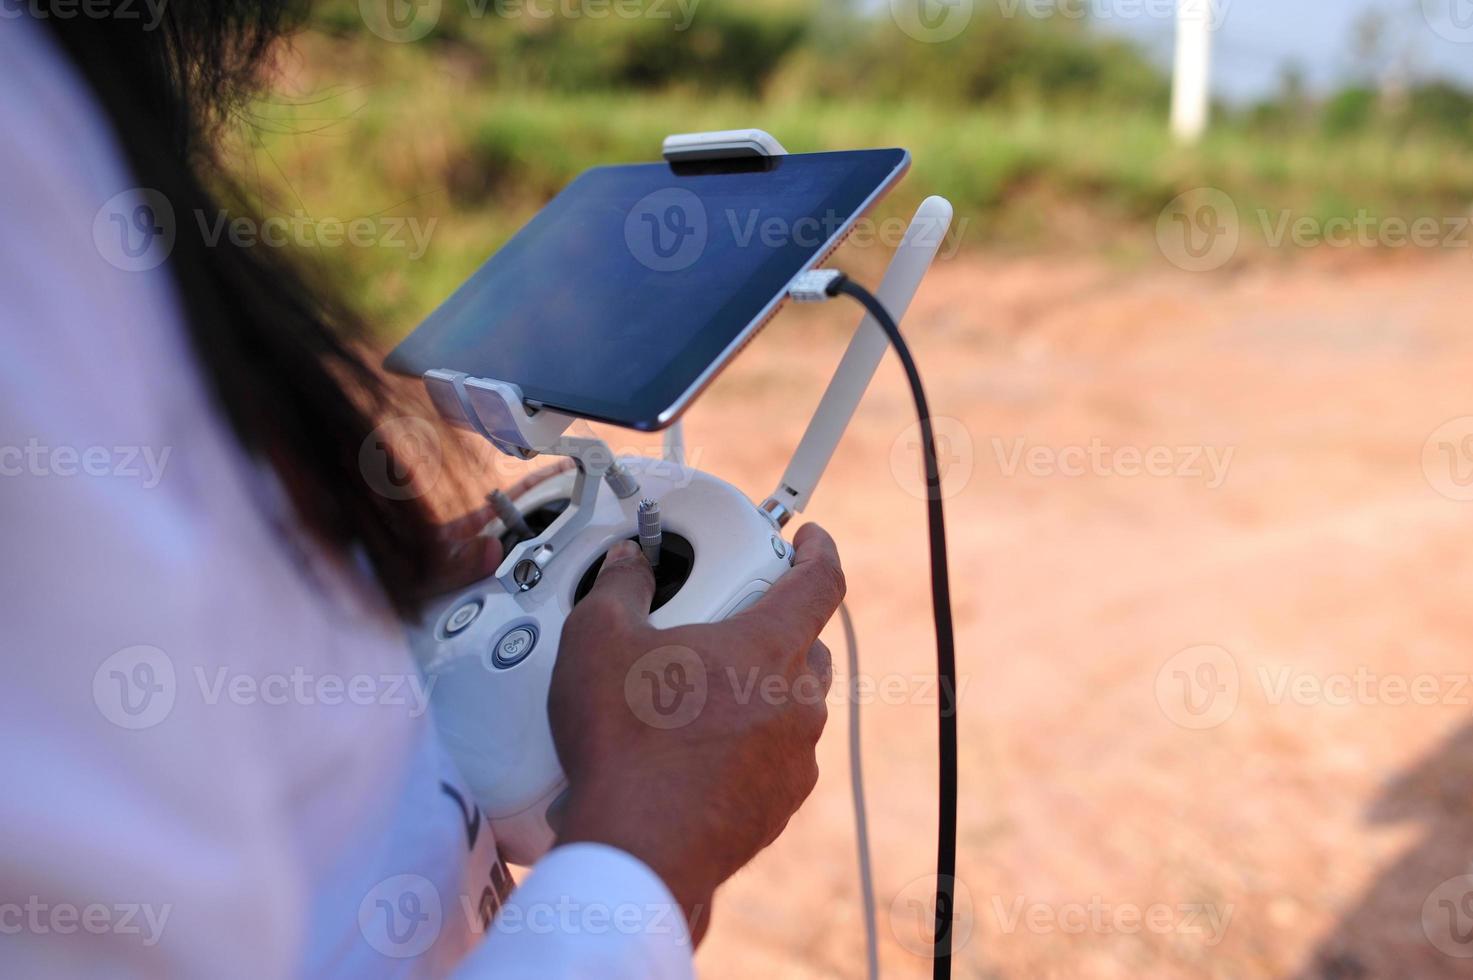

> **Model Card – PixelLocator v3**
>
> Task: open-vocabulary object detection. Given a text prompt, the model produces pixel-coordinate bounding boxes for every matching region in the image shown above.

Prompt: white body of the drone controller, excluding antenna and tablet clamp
[411,457,792,865]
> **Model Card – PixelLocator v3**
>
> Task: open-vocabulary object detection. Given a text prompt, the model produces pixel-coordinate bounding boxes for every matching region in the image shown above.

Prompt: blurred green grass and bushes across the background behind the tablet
[243,0,1473,332]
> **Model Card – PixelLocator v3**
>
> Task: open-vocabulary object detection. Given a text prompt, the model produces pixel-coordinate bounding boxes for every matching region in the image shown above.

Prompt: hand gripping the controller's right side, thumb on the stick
[548,525,844,942]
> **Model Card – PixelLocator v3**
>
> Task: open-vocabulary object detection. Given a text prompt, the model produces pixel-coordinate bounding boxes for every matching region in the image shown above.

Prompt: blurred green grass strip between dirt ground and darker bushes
[242,38,1473,333]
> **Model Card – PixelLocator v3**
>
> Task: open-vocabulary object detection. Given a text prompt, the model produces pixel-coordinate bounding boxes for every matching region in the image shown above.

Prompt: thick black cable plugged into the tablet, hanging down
[825,276,957,980]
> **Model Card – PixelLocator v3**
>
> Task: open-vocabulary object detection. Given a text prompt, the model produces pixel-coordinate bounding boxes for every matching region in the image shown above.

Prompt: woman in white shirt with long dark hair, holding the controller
[0,0,843,977]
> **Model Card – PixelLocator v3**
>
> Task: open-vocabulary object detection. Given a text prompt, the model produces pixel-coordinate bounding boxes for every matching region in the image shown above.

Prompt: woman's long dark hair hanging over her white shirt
[46,0,437,613]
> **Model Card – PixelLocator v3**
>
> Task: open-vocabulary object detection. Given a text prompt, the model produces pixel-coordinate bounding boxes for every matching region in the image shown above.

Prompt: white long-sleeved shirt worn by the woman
[0,18,692,980]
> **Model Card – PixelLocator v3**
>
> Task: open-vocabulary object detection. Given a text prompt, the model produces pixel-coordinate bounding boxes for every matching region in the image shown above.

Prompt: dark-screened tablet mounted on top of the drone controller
[386,149,910,430]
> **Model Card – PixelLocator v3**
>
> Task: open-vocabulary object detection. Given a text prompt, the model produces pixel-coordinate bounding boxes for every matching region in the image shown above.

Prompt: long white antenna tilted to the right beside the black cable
[762,197,952,525]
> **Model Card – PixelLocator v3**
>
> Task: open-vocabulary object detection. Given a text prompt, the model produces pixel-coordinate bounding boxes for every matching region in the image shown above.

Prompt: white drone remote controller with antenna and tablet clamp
[411,130,952,865]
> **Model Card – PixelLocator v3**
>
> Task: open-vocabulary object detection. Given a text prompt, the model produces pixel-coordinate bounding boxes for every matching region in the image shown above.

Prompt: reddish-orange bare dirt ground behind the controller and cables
[642,249,1473,980]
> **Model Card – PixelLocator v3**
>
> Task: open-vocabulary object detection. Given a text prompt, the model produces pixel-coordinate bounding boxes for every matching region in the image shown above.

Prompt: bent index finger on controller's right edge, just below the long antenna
[739,525,844,657]
